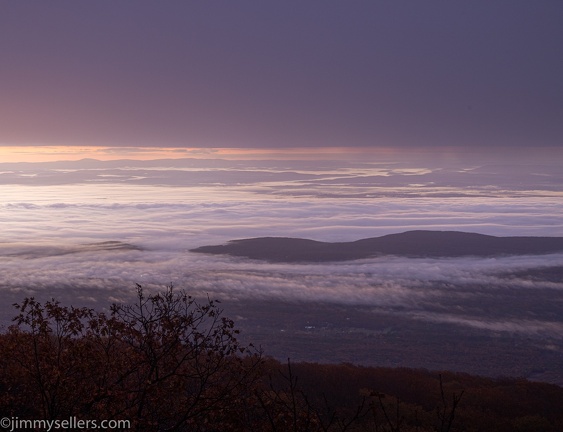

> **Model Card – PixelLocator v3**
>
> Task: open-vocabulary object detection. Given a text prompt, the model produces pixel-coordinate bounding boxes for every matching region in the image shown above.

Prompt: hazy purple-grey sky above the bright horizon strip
[0,0,563,148]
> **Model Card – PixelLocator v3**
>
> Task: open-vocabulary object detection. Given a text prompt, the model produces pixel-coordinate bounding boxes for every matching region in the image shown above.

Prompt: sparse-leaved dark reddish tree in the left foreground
[2,285,262,430]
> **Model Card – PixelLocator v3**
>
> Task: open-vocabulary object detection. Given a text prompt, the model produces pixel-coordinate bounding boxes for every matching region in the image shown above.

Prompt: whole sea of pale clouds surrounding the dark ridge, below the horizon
[0,159,563,339]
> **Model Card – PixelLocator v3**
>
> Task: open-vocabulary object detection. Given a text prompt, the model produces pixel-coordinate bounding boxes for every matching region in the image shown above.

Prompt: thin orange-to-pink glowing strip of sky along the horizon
[0,145,563,166]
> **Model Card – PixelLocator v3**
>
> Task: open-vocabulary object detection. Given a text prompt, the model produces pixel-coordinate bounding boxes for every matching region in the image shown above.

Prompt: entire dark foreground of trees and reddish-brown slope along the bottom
[0,287,563,432]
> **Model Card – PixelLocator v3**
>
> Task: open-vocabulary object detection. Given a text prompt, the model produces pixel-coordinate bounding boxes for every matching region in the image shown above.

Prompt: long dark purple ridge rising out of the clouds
[191,230,563,262]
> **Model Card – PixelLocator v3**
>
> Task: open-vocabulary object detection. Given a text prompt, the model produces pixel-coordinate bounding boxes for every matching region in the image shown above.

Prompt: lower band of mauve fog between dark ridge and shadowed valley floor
[0,241,563,338]
